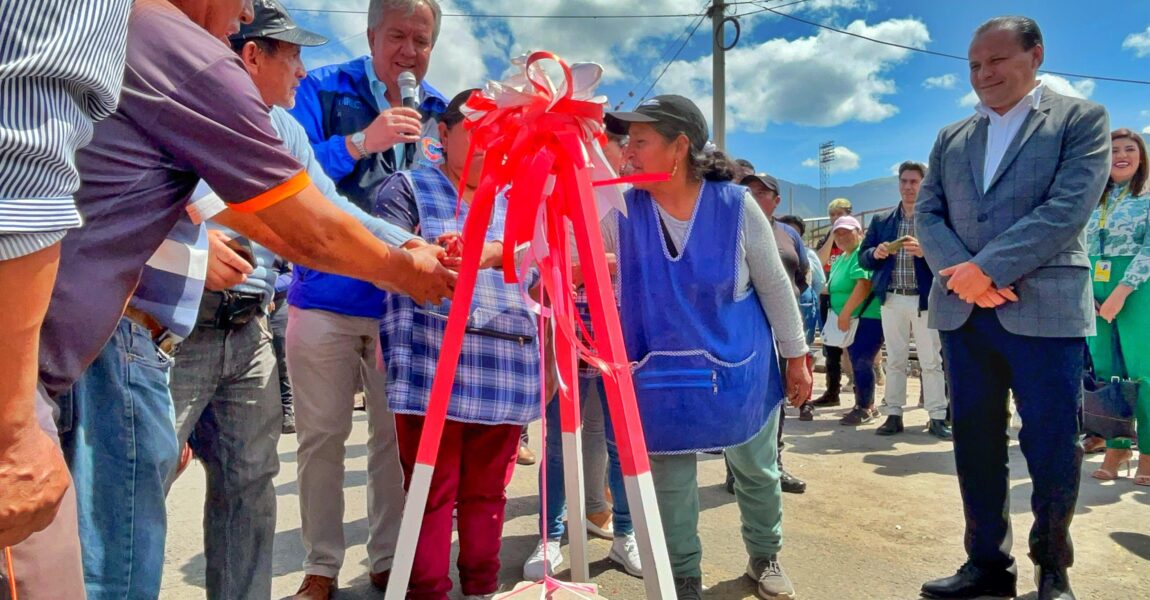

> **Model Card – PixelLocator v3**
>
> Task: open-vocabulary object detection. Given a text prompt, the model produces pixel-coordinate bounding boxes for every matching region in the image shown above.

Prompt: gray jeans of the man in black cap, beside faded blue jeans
[169,317,283,600]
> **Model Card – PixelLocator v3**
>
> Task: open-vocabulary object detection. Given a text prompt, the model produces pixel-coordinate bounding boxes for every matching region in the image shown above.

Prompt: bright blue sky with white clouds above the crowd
[292,0,1150,185]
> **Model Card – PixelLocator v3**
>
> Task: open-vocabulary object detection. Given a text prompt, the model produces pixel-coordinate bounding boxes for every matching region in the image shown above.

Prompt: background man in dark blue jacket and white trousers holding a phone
[859,161,951,440]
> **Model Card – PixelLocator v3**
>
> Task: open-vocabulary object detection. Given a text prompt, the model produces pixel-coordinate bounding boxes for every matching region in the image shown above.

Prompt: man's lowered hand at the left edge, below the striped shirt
[0,423,71,547]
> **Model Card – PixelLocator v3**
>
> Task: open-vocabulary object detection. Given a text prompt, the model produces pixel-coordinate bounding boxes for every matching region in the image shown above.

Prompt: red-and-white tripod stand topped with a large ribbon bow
[386,52,675,600]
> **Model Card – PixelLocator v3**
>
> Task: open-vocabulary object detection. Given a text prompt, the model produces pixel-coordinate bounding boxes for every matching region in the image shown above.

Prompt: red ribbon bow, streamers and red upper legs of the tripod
[416,52,667,476]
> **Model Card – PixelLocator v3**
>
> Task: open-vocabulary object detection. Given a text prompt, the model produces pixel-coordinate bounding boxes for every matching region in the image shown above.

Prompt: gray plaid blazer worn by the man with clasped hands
[914,89,1110,338]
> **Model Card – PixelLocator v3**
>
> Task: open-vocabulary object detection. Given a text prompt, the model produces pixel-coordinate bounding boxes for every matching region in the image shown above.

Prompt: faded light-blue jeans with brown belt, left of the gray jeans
[59,318,179,600]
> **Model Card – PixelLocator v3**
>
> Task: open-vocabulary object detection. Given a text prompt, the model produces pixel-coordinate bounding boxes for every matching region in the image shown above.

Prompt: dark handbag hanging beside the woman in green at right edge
[1082,318,1140,439]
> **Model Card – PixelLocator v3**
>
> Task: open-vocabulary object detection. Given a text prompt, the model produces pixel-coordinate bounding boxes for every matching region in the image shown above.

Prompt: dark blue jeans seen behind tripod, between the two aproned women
[539,377,635,539]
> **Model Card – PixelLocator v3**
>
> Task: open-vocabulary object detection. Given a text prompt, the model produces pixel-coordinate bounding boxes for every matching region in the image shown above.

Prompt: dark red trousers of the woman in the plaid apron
[396,415,523,600]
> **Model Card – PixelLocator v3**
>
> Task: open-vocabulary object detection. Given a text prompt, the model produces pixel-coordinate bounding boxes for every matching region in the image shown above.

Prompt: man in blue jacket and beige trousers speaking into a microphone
[285,0,447,599]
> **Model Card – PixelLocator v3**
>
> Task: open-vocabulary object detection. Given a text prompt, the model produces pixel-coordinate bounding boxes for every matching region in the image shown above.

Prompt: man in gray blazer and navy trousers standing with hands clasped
[915,12,1110,600]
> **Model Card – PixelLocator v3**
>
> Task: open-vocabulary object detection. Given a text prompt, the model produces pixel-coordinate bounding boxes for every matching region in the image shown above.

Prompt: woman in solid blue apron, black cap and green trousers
[603,95,811,600]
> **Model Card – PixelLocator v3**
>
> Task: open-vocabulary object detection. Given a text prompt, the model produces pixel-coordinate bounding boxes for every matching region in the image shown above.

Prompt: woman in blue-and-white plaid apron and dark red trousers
[375,91,541,600]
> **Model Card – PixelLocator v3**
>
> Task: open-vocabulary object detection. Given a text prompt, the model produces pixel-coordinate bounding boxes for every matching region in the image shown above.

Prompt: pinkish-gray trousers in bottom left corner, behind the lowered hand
[0,387,85,600]
